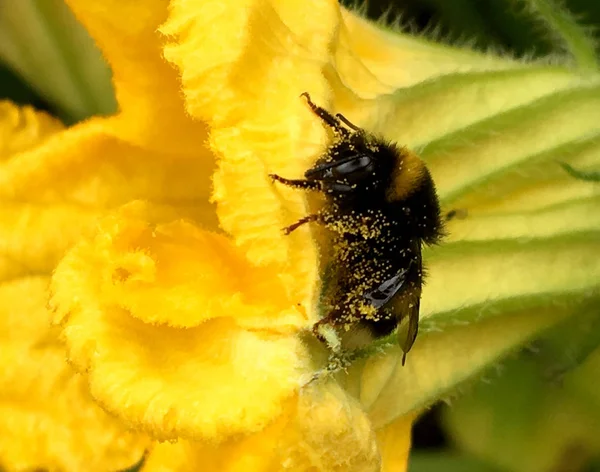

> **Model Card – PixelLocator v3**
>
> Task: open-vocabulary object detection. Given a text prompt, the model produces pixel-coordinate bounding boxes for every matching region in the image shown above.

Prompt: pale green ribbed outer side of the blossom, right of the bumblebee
[318,26,600,436]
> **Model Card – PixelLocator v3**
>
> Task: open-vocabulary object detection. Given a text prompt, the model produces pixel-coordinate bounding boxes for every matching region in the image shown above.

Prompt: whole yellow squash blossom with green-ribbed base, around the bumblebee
[0,0,600,472]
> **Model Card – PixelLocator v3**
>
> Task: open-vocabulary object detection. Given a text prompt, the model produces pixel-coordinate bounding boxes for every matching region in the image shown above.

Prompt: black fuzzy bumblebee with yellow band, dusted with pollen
[270,93,443,365]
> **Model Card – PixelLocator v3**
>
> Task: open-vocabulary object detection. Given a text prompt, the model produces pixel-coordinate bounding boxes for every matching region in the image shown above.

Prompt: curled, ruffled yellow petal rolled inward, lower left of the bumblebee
[52,208,308,441]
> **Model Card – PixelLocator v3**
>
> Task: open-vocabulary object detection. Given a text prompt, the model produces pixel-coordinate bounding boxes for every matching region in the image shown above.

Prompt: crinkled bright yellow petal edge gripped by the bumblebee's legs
[162,0,328,301]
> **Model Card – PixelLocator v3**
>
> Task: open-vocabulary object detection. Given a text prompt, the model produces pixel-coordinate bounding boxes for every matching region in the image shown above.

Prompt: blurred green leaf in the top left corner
[0,0,116,123]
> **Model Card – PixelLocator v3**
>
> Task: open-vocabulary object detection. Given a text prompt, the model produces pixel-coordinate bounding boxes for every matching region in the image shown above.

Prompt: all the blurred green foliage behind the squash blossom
[0,0,600,472]
